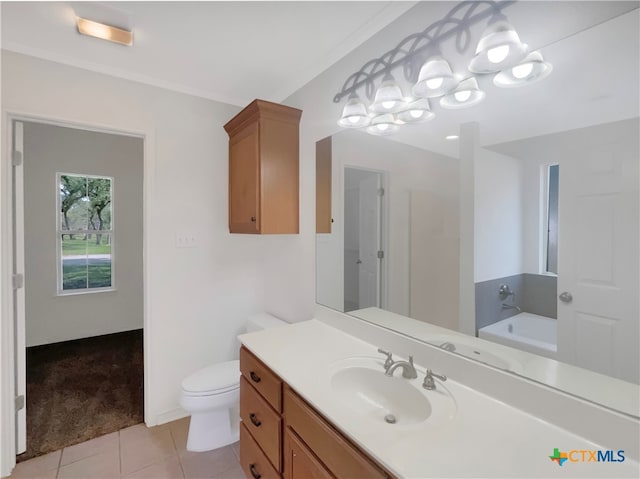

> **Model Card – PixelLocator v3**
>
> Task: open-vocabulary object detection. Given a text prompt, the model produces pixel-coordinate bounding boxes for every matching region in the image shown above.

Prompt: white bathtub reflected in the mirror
[478,313,558,359]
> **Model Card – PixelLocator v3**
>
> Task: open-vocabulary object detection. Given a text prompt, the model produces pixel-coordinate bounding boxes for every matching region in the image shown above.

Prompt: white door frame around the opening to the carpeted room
[0,110,156,477]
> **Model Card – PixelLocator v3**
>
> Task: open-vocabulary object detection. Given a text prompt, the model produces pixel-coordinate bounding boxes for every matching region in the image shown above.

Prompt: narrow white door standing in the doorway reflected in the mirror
[358,173,382,308]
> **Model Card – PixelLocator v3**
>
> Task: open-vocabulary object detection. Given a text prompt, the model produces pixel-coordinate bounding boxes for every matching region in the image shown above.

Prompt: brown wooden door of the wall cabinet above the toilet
[229,123,260,233]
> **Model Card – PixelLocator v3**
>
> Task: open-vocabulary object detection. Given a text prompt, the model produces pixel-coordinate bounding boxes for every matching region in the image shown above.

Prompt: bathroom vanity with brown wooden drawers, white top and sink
[240,313,639,479]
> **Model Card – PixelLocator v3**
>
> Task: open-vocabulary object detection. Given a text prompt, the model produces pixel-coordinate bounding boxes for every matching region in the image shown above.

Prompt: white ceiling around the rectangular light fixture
[2,1,413,106]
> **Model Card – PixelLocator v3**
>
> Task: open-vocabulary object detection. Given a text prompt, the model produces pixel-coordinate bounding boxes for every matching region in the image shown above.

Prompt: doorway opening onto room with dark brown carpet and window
[12,120,144,461]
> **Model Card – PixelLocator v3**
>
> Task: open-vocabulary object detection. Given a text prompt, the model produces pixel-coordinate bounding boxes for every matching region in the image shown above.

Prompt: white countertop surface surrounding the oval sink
[239,320,640,478]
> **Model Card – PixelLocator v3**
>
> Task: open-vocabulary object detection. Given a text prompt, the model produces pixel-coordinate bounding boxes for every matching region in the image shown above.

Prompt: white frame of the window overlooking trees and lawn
[55,172,116,296]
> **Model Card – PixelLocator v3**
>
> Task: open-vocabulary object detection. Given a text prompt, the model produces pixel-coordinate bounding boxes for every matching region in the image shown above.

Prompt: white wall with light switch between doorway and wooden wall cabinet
[0,52,270,429]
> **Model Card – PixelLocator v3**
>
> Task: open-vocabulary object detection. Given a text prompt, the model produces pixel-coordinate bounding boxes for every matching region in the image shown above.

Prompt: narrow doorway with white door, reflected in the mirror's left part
[344,167,384,312]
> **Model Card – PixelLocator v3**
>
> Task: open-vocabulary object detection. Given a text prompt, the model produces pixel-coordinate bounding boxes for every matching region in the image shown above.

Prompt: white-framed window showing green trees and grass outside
[57,173,113,294]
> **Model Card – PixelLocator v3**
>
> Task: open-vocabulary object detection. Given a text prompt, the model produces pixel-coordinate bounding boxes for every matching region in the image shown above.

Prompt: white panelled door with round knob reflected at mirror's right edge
[558,137,640,382]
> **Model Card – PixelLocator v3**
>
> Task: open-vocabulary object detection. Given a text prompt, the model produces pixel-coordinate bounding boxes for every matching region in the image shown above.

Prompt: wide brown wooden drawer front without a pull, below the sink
[284,387,392,479]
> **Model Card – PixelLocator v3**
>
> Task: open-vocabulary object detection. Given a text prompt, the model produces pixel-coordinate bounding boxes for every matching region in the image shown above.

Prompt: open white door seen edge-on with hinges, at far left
[11,121,27,454]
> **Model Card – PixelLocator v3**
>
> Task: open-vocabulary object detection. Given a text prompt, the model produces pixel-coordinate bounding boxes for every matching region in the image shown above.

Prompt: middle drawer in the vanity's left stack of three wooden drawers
[240,377,282,471]
